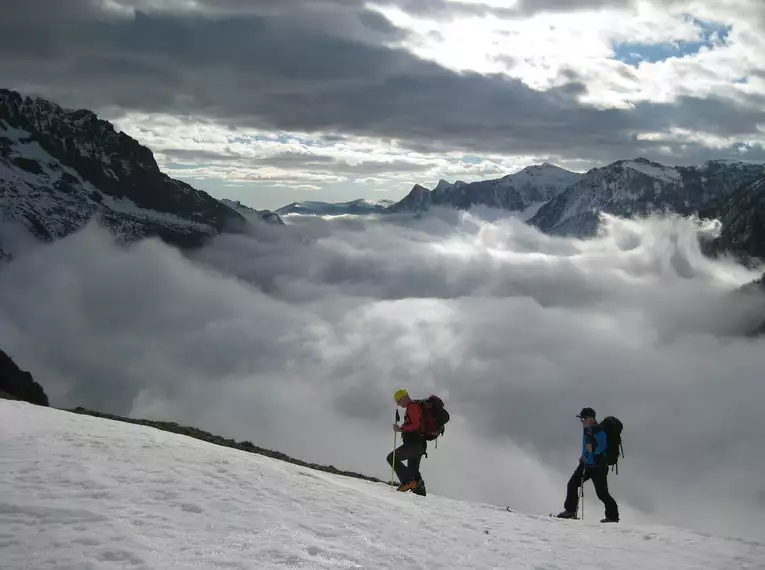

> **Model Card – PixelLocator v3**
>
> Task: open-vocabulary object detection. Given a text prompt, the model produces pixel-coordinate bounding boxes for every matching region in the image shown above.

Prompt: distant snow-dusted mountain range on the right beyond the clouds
[277,158,765,270]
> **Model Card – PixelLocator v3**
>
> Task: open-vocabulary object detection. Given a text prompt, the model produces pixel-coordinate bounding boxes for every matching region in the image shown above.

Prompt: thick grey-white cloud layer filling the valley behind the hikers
[0,212,765,538]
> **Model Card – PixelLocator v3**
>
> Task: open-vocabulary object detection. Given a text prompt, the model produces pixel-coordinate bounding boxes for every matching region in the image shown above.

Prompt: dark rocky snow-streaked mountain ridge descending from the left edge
[0,90,281,258]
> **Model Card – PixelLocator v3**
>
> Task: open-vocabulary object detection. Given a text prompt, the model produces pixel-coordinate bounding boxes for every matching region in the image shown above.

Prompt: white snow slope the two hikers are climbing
[0,400,765,570]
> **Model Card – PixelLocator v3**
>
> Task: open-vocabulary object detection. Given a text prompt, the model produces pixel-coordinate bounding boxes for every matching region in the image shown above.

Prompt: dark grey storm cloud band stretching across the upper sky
[0,0,765,165]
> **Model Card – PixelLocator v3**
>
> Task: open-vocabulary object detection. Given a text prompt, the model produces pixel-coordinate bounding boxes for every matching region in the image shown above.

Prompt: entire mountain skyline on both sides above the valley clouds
[0,89,765,272]
